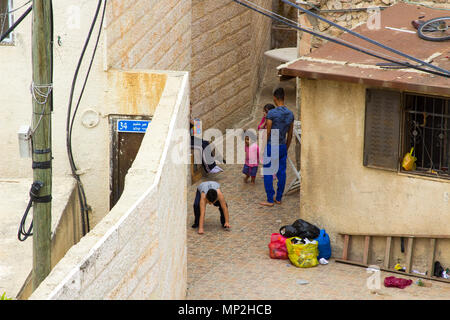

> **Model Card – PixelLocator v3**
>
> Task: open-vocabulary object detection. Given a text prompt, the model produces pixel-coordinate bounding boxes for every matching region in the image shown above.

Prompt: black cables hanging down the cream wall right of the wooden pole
[66,0,107,235]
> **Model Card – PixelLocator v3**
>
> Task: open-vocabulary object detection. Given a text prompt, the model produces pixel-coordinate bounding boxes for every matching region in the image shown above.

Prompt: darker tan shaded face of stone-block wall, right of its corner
[191,0,271,130]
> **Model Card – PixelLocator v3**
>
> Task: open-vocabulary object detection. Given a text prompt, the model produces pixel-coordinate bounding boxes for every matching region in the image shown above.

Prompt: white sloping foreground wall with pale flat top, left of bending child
[30,73,189,299]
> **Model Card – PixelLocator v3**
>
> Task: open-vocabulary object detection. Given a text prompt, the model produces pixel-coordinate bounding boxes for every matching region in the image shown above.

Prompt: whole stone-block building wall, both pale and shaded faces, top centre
[106,0,272,130]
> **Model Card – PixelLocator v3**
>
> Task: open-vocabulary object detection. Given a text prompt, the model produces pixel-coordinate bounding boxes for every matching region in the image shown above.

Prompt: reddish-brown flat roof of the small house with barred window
[279,3,450,96]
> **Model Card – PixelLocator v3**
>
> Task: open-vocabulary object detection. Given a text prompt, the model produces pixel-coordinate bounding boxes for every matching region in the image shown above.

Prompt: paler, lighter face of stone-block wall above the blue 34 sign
[106,0,191,71]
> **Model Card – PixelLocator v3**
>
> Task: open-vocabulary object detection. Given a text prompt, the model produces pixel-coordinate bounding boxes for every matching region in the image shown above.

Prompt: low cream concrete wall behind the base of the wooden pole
[0,177,82,299]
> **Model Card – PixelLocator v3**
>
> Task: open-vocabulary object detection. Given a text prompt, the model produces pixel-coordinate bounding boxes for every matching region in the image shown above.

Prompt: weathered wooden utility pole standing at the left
[31,0,53,290]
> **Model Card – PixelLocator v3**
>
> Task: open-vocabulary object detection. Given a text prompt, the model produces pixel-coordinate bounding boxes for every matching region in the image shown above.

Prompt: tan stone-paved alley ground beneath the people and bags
[187,80,450,300]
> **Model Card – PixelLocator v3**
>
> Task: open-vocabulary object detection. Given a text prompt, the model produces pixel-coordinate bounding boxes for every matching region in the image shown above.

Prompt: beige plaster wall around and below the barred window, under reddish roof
[300,79,450,270]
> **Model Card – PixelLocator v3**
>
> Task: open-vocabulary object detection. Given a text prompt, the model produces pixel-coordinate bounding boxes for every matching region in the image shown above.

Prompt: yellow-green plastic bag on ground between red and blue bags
[286,237,319,268]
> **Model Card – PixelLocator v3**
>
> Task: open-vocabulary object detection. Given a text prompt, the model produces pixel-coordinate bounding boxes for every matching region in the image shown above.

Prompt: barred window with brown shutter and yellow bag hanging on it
[363,89,450,179]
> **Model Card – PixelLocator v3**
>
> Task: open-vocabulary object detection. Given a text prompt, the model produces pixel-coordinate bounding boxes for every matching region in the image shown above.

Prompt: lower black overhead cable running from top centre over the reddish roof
[233,0,450,77]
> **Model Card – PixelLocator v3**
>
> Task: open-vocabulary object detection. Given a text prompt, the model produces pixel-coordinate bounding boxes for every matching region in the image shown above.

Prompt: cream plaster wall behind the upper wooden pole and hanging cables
[0,0,109,226]
